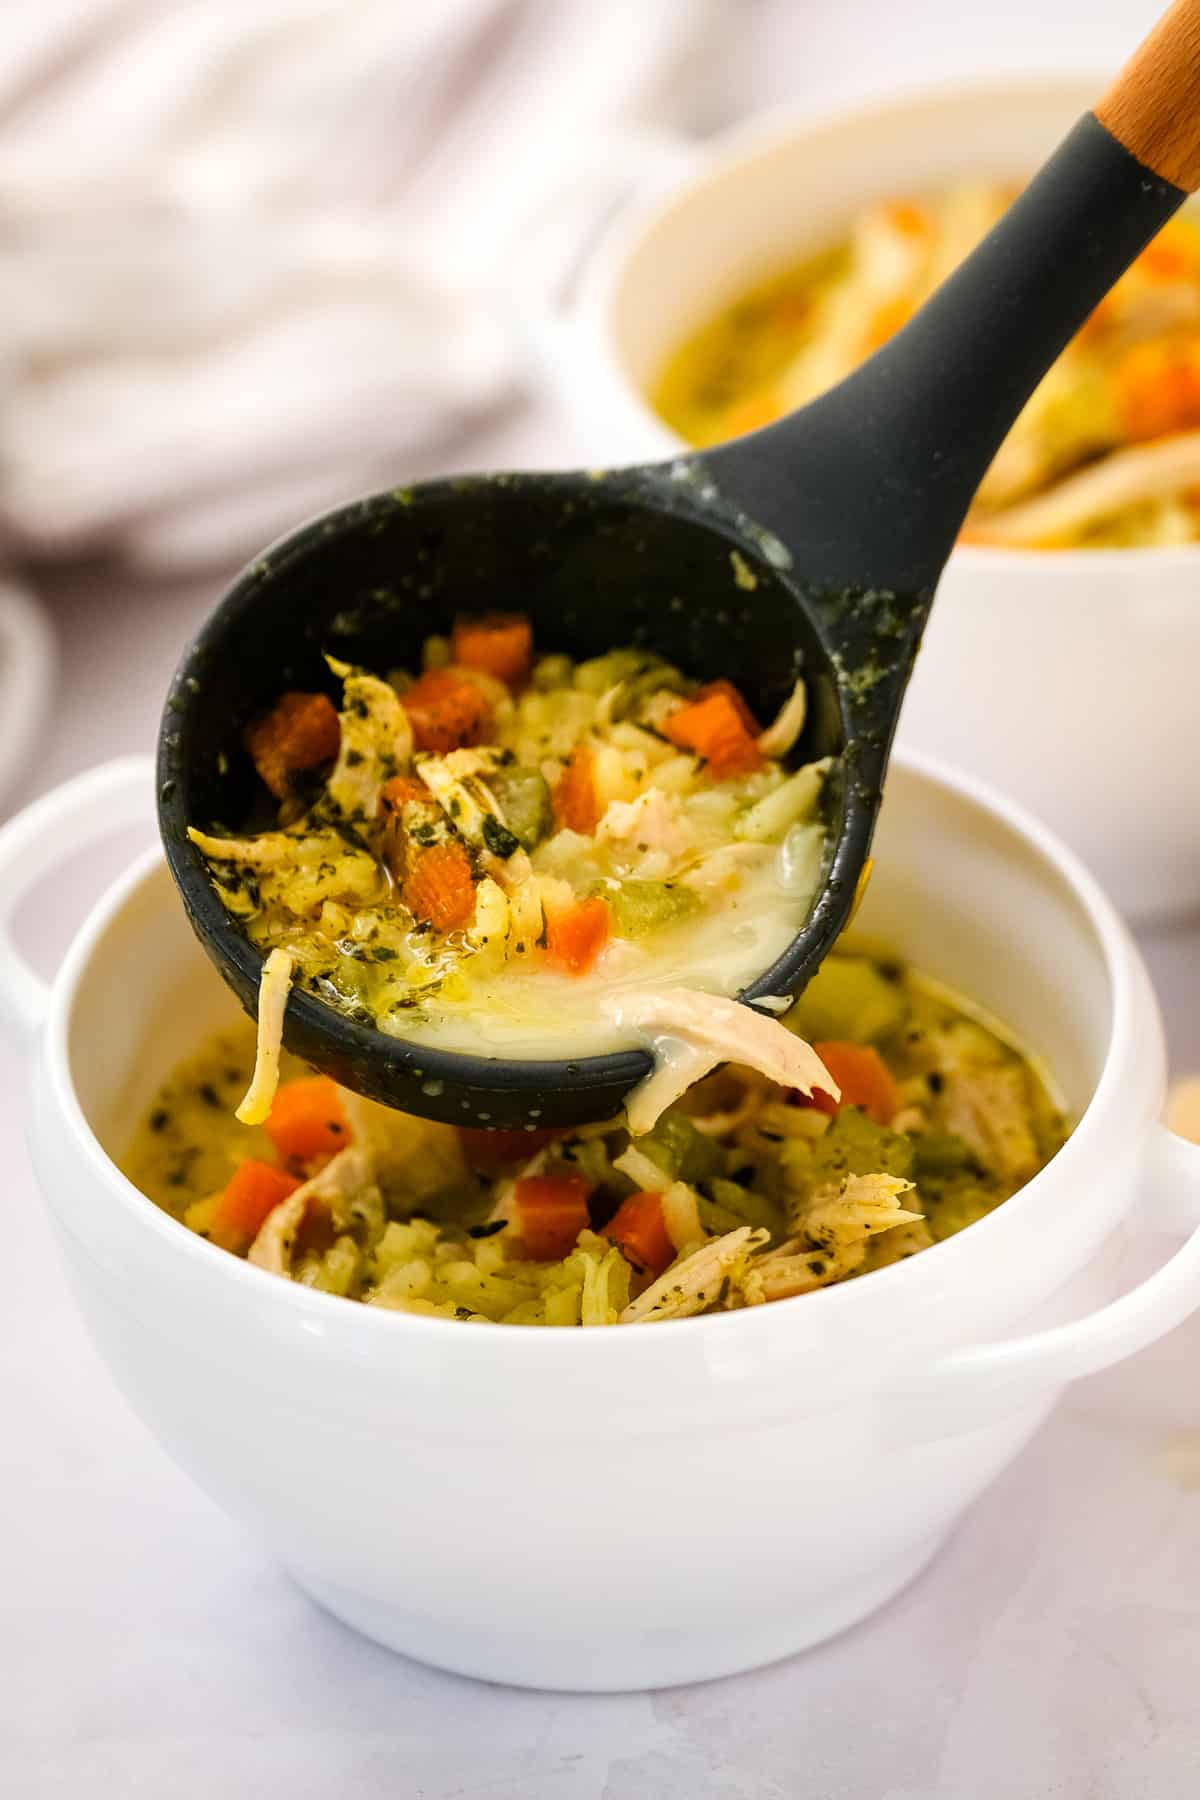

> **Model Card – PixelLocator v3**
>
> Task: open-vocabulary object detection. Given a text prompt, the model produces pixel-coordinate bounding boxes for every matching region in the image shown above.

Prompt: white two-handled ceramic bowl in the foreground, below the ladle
[0,758,1200,1690]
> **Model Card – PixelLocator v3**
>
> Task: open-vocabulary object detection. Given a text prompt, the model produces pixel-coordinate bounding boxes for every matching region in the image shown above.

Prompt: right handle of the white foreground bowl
[905,1123,1200,1429]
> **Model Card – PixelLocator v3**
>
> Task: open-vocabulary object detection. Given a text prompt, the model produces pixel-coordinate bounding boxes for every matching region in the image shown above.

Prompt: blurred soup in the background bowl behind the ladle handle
[655,184,1200,549]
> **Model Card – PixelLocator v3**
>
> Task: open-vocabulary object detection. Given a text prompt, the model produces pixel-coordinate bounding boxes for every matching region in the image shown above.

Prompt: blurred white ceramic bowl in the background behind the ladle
[509,77,1200,916]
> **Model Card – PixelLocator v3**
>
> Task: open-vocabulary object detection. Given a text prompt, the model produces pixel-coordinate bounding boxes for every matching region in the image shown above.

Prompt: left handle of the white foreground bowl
[0,756,155,1048]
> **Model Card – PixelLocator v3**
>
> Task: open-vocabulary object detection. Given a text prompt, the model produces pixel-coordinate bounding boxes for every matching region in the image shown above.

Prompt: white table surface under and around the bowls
[0,379,1200,1800]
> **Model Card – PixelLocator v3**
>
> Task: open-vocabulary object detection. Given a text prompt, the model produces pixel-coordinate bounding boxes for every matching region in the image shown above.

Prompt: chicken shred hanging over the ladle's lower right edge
[604,988,842,1138]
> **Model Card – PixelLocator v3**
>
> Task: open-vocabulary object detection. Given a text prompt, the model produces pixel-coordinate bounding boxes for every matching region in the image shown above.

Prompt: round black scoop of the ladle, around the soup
[158,463,910,1127]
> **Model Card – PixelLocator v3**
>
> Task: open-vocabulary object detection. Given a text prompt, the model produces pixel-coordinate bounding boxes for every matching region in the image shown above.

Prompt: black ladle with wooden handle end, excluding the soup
[158,0,1200,1127]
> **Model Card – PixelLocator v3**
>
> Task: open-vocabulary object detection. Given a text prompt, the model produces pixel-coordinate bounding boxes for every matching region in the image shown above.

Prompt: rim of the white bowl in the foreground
[43,751,1139,1357]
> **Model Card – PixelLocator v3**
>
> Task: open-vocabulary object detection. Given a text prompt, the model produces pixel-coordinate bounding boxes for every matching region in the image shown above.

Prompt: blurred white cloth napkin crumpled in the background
[0,0,734,569]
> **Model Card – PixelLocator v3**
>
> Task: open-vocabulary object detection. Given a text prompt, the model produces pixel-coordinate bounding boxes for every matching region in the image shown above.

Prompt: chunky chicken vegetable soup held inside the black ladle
[191,616,841,1123]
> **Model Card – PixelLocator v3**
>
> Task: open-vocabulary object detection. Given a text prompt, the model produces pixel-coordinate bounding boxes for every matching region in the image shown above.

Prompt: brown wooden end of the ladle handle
[1096,0,1200,194]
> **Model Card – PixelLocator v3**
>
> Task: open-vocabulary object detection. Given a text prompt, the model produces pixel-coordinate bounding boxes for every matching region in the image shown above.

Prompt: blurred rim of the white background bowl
[576,68,1200,576]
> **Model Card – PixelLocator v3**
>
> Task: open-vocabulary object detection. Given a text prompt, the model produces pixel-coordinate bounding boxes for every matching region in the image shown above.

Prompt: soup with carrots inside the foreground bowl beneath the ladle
[124,952,1065,1325]
